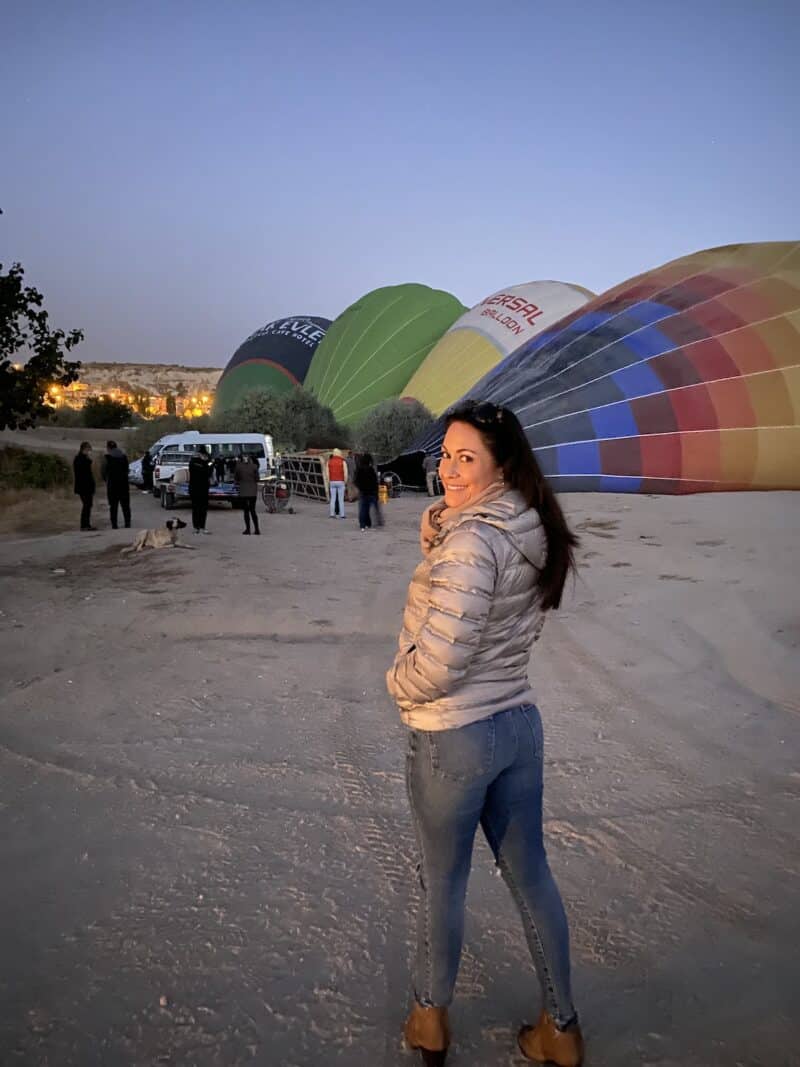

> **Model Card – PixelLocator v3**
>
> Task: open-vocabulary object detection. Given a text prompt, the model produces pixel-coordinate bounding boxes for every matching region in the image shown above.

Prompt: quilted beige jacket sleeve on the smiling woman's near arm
[386,526,497,707]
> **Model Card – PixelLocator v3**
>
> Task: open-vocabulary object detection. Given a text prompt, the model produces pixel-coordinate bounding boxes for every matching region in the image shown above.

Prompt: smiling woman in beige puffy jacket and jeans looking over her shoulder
[387,403,583,1067]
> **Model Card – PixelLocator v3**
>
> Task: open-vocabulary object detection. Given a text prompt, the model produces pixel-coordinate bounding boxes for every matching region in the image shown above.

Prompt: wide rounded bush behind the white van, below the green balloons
[213,386,349,452]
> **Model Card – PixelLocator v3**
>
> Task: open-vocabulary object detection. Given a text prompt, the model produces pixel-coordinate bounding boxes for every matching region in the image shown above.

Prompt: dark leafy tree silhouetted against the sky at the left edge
[0,264,83,430]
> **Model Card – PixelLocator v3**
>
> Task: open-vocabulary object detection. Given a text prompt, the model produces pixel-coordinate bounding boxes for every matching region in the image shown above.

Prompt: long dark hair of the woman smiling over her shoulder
[445,401,578,611]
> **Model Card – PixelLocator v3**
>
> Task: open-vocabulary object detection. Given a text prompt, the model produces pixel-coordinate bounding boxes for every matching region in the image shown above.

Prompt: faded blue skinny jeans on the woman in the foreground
[405,704,575,1028]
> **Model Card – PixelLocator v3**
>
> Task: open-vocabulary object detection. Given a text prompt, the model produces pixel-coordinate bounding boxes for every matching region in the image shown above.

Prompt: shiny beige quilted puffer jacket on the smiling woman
[386,490,546,730]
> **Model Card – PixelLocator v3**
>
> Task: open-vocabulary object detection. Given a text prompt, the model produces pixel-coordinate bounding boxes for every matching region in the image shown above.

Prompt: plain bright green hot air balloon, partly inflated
[305,283,465,424]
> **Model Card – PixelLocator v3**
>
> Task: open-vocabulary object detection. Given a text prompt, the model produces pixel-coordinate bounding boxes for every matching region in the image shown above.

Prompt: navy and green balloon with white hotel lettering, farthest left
[214,315,331,411]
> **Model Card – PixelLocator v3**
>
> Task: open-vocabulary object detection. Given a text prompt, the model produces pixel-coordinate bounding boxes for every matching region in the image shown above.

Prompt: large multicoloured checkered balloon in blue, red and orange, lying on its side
[412,242,800,493]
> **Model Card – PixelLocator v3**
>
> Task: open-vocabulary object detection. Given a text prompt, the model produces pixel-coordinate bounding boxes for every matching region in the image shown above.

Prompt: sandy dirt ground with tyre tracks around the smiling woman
[0,493,800,1067]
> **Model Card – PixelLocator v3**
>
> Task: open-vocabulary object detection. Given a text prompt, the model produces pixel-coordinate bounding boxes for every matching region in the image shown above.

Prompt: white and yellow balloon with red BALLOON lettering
[403,282,594,415]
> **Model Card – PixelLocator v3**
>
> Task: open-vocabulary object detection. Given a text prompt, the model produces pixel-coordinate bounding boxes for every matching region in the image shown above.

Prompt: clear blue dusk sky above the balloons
[0,0,800,366]
